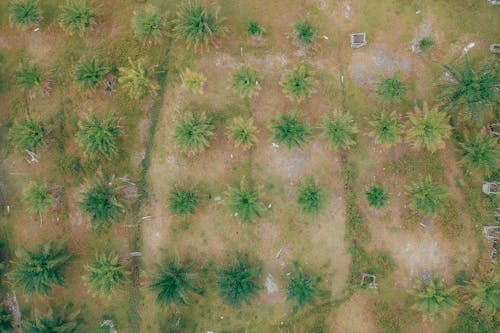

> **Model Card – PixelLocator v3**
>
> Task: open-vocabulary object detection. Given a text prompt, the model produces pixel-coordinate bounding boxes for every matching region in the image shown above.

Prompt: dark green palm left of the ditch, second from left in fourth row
[80,180,125,231]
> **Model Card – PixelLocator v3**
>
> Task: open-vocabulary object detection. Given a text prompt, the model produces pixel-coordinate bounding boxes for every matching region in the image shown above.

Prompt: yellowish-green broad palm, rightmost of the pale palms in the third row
[407,104,451,153]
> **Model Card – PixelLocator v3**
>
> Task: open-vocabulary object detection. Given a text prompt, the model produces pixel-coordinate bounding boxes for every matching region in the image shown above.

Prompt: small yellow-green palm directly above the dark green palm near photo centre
[280,64,316,102]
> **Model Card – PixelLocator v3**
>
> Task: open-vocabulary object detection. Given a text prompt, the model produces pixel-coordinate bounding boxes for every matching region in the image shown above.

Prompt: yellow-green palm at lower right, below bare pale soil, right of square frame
[411,279,456,320]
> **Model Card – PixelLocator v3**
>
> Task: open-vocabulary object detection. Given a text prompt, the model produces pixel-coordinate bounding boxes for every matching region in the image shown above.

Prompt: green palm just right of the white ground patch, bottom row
[286,263,320,308]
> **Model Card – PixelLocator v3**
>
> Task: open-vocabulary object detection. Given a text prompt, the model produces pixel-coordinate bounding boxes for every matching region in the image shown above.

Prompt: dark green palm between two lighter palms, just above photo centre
[271,113,311,149]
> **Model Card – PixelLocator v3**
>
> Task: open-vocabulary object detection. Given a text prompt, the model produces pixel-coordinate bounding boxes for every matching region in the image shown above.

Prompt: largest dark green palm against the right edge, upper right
[438,57,500,124]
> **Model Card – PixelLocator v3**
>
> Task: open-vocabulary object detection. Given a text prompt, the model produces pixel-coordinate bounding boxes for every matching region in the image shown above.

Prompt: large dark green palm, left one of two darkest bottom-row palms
[149,260,203,306]
